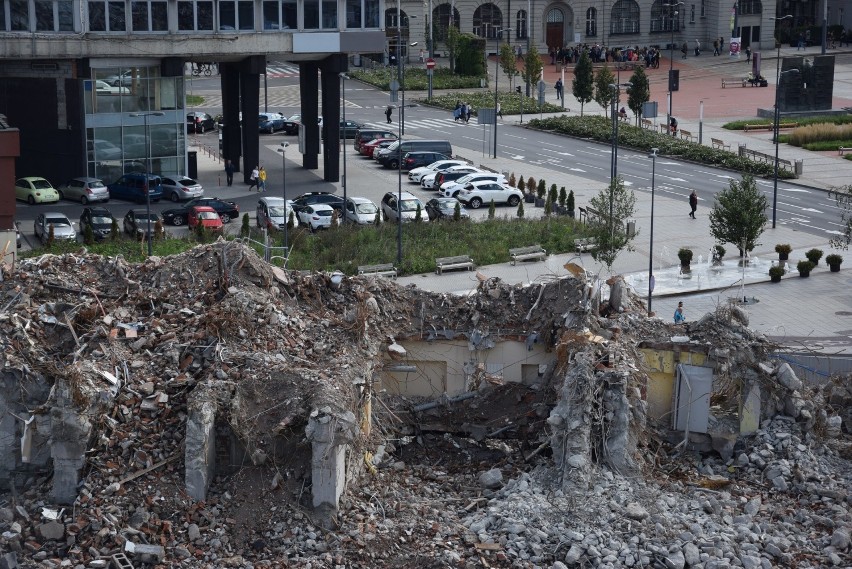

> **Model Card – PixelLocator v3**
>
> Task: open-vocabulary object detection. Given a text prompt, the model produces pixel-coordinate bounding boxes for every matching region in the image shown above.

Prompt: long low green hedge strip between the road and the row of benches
[529,115,794,178]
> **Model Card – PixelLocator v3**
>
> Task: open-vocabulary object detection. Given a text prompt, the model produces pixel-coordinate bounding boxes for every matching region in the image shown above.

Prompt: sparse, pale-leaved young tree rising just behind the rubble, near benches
[589,176,639,272]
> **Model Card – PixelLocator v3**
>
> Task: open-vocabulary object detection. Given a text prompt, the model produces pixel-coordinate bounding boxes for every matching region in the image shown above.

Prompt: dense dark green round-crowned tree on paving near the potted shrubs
[710,174,768,256]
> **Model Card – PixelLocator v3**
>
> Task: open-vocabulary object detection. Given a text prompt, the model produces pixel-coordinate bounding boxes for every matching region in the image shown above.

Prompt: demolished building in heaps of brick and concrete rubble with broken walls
[0,240,852,569]
